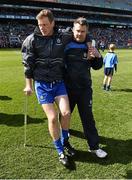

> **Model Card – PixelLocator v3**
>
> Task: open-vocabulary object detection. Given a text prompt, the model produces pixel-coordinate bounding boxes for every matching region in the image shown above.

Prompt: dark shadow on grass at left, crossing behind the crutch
[0,113,46,127]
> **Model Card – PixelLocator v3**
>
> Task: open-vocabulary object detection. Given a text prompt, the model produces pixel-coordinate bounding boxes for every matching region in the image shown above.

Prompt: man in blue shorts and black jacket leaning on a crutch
[22,9,75,166]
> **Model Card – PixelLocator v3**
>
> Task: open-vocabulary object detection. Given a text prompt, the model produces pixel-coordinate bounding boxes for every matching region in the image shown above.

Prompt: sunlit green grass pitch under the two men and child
[0,49,132,179]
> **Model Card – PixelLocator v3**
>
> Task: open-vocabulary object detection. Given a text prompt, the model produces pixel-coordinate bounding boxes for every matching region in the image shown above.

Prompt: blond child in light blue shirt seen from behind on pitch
[103,44,118,91]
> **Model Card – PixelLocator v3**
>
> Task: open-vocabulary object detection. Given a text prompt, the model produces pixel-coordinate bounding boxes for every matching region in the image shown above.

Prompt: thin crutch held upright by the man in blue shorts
[24,95,28,147]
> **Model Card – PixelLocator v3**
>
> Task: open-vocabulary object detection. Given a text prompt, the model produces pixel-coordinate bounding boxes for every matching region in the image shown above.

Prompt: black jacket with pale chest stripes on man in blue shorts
[22,28,72,82]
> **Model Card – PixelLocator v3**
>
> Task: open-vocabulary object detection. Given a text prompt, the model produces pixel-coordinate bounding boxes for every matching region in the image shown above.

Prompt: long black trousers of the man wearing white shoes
[67,88,99,150]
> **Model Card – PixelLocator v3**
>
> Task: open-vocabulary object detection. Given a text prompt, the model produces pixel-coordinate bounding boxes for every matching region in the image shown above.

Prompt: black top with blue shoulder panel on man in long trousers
[65,41,103,91]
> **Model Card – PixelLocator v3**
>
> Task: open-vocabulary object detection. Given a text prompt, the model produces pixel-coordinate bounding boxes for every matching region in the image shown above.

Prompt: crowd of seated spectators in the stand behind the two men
[0,22,132,48]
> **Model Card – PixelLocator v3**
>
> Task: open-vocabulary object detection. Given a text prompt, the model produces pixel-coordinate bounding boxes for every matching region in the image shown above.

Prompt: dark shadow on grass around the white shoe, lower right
[70,130,132,165]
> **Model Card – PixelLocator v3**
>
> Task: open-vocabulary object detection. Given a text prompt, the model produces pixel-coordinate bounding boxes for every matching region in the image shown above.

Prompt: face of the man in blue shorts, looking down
[38,17,54,36]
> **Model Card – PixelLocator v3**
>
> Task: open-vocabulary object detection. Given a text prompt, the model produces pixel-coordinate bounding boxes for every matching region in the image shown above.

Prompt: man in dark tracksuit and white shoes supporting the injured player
[65,18,107,158]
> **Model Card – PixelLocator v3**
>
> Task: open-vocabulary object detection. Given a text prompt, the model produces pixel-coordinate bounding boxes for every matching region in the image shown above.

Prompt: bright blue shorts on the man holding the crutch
[35,80,67,104]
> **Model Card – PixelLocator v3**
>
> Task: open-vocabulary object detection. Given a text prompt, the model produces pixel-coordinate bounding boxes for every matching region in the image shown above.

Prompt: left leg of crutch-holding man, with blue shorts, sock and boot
[35,82,68,166]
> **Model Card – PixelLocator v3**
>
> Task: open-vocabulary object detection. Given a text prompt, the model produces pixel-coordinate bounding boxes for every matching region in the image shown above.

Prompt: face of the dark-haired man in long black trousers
[73,24,88,42]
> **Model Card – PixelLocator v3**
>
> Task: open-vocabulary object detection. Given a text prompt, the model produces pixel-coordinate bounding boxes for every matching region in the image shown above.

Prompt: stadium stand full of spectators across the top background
[0,0,132,48]
